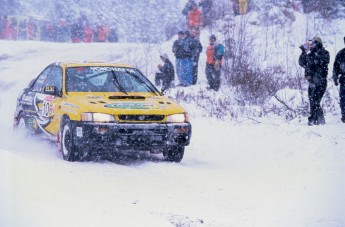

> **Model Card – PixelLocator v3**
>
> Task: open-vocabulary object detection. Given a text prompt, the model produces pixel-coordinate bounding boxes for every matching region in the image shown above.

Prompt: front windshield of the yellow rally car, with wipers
[66,66,159,94]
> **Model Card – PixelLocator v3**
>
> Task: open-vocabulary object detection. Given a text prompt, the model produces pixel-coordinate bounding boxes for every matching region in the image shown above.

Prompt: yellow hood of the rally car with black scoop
[62,92,185,115]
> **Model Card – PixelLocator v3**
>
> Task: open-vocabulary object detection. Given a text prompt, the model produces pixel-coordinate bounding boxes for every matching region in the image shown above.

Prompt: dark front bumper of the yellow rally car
[72,121,192,150]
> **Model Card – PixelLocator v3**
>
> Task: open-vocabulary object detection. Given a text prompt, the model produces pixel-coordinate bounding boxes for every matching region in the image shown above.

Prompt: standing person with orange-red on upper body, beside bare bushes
[205,35,222,91]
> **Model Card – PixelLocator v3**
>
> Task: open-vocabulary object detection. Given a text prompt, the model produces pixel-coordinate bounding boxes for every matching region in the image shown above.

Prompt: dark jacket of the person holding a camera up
[299,43,329,84]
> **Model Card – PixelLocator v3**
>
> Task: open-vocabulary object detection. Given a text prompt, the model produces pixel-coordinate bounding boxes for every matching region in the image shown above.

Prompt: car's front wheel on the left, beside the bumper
[60,119,79,162]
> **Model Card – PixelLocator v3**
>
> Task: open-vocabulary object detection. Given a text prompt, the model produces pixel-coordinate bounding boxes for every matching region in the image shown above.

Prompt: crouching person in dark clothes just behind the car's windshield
[155,54,175,93]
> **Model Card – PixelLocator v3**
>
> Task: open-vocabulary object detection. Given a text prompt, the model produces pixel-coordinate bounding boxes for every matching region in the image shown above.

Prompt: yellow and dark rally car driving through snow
[14,62,191,162]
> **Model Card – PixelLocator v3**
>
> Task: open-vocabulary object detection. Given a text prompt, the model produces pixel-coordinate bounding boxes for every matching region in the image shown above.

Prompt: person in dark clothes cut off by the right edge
[333,37,345,123]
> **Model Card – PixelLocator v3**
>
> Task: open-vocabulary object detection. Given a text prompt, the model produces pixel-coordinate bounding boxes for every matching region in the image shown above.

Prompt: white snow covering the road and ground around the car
[0,41,345,227]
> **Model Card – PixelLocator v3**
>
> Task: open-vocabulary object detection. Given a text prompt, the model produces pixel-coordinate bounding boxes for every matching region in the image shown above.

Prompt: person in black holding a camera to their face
[299,37,330,125]
